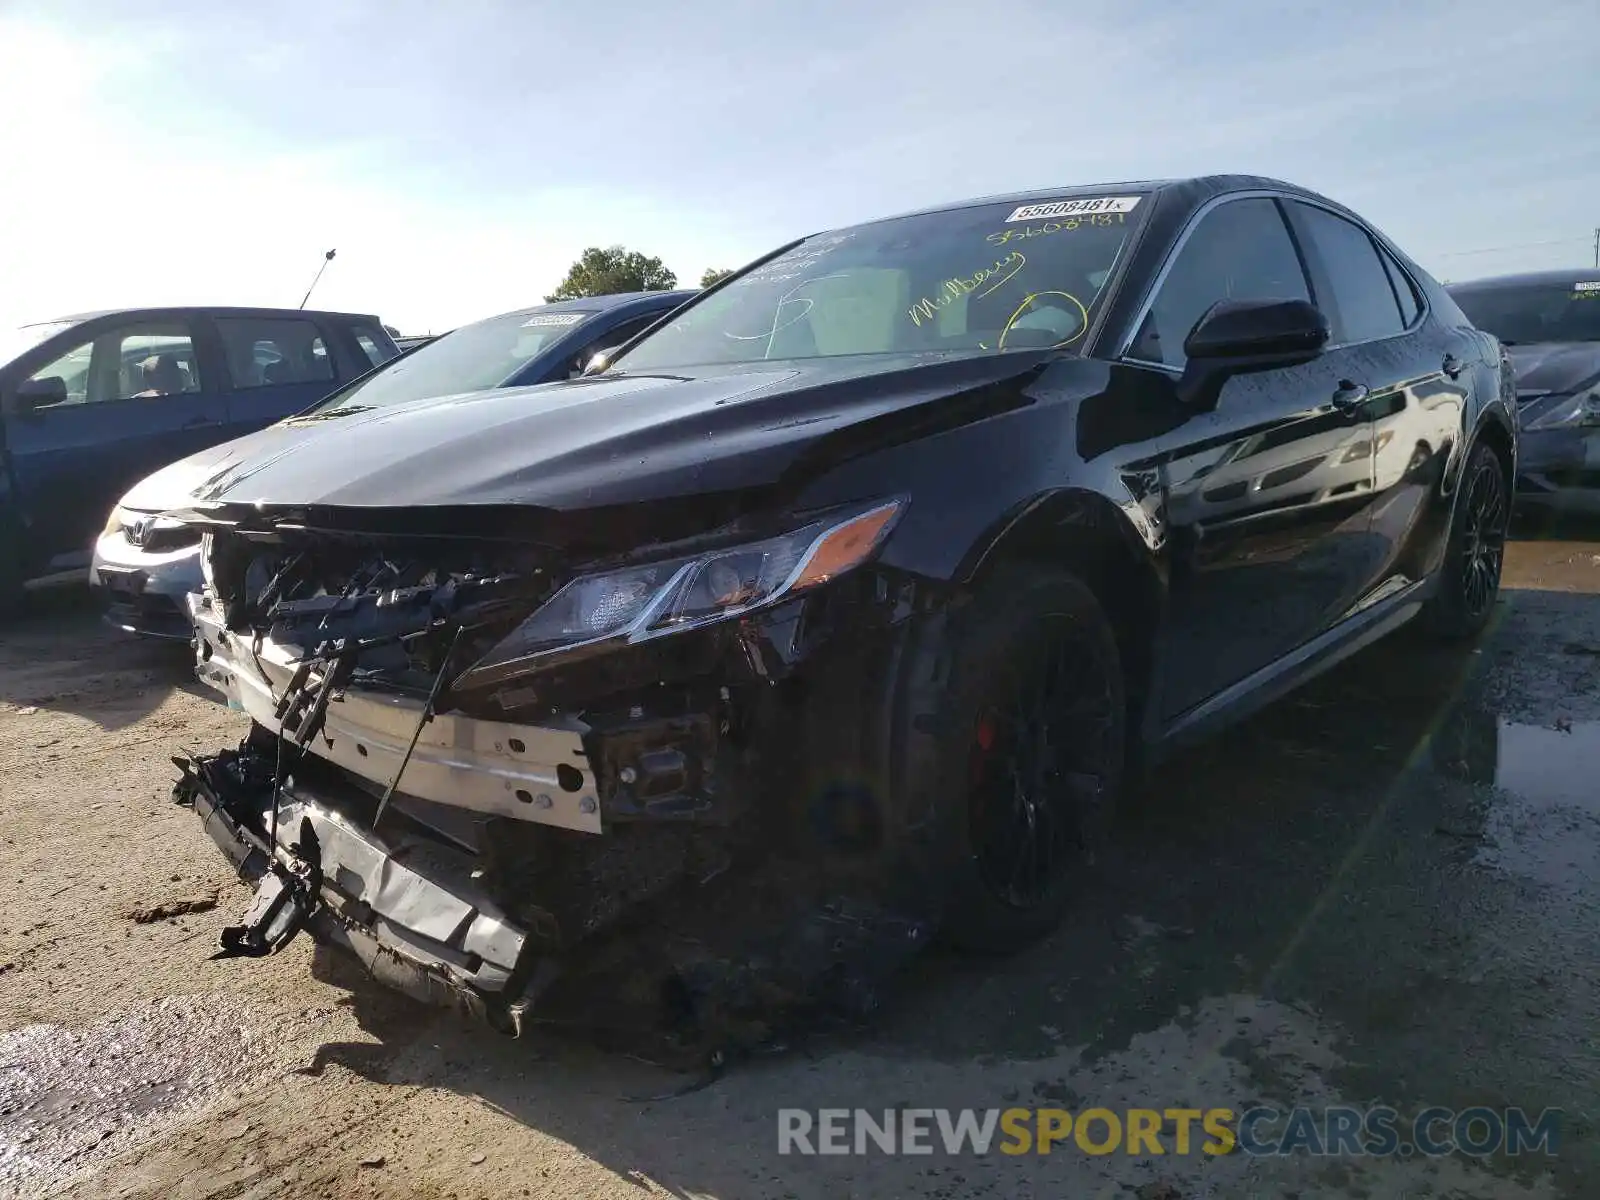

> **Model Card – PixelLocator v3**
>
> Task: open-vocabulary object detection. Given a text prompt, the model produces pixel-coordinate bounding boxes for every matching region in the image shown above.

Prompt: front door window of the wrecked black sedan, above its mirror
[1128,197,1312,371]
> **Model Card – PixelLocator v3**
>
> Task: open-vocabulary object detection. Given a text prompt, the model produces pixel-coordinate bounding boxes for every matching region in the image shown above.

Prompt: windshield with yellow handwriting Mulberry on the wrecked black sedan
[618,194,1144,371]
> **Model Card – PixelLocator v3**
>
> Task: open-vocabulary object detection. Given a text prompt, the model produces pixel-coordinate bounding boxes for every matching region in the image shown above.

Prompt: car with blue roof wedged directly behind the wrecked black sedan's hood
[90,291,694,640]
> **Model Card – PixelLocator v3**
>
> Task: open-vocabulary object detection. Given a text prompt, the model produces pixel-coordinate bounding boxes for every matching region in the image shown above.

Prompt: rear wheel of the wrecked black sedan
[1422,442,1510,642]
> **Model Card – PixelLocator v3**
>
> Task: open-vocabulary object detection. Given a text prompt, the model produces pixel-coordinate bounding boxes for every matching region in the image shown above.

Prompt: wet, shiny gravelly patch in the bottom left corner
[0,995,318,1195]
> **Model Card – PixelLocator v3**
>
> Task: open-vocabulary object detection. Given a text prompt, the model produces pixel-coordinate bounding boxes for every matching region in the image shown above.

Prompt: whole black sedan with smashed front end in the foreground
[178,178,1517,1043]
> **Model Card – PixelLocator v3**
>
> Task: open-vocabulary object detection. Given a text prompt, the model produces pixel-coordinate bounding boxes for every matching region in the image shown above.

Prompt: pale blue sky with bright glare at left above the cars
[0,0,1600,333]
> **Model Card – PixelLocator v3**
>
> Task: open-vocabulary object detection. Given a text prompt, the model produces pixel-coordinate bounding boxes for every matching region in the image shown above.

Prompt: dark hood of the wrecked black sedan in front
[184,352,1045,528]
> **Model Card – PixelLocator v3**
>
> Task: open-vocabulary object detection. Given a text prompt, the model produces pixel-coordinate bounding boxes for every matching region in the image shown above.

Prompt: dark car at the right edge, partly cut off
[1450,270,1600,499]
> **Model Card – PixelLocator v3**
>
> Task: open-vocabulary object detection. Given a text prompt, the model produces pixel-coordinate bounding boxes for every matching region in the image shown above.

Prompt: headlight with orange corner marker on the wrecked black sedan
[462,501,901,683]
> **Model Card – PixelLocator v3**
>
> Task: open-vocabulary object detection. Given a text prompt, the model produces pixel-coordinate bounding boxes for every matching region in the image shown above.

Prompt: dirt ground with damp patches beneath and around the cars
[0,536,1600,1200]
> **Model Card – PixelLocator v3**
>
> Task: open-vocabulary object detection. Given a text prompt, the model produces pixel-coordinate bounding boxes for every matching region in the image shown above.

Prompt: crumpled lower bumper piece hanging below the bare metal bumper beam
[173,752,555,1032]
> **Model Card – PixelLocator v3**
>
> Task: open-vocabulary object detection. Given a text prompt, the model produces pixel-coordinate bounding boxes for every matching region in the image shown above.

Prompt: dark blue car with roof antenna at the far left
[0,307,398,608]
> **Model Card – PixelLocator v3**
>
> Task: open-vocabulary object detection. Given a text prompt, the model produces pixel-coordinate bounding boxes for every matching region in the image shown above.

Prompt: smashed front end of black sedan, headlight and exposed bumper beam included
[174,498,941,1056]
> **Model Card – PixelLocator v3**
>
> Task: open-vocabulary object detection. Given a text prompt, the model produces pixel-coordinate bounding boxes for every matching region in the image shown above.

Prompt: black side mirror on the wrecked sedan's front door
[1178,299,1331,408]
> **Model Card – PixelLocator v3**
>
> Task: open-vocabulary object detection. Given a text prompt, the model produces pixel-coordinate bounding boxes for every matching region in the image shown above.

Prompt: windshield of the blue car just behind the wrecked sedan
[314,309,594,416]
